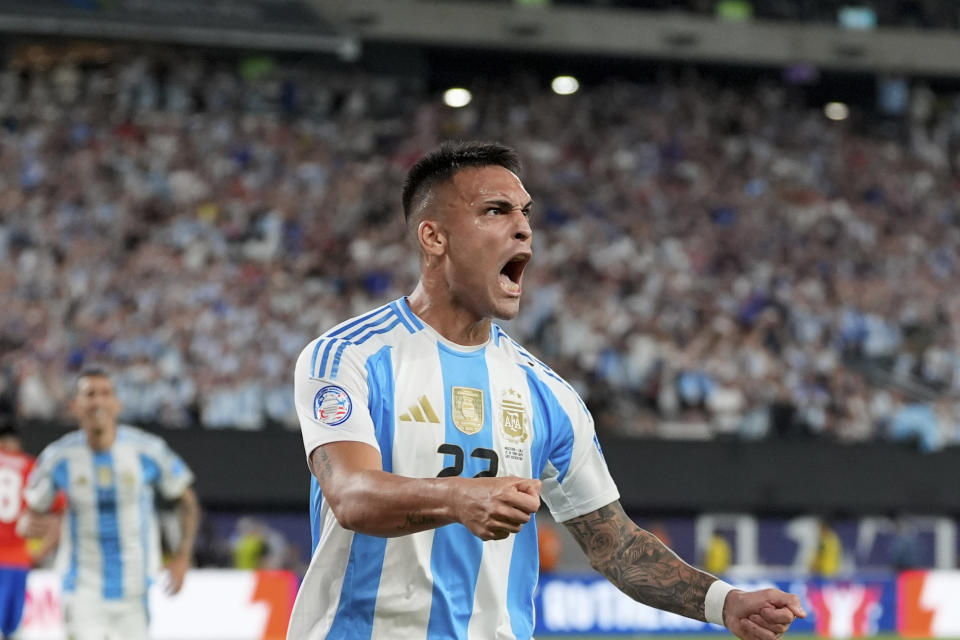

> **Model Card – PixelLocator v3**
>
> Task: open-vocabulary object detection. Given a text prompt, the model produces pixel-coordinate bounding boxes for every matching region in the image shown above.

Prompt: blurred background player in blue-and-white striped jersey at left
[25,369,199,640]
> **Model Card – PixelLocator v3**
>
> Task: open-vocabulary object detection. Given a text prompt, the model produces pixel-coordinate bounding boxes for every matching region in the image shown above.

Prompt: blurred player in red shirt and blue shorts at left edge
[0,417,57,638]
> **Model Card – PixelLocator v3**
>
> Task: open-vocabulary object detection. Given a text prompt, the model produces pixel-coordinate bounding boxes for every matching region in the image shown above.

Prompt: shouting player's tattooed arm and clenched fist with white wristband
[564,502,806,640]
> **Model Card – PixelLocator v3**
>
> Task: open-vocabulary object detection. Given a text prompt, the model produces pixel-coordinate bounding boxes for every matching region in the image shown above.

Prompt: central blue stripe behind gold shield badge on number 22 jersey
[427,344,493,638]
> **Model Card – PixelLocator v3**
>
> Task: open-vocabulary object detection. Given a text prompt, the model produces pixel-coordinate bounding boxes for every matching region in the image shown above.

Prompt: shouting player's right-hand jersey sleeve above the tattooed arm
[541,380,620,522]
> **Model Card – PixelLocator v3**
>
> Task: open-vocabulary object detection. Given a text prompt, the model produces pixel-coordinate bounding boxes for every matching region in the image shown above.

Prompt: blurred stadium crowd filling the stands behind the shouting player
[0,47,960,450]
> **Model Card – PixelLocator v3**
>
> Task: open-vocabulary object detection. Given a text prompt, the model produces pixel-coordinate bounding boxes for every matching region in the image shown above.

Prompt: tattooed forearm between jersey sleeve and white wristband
[564,502,715,620]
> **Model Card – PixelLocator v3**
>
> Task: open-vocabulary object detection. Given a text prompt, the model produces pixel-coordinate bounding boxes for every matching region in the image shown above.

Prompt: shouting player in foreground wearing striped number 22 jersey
[288,143,805,640]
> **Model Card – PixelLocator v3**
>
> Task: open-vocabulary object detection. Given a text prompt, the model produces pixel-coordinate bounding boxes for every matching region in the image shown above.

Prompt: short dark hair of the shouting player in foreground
[403,141,520,222]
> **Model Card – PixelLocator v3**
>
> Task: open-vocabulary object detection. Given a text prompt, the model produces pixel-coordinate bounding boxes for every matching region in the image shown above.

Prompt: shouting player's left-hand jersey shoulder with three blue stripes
[297,298,423,378]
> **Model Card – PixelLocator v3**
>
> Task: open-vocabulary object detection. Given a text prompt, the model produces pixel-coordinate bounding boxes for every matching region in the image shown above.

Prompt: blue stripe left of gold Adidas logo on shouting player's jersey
[326,347,396,640]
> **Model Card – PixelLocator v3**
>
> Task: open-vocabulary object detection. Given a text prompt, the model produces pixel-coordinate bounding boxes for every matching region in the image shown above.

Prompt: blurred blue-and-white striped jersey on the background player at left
[24,425,193,601]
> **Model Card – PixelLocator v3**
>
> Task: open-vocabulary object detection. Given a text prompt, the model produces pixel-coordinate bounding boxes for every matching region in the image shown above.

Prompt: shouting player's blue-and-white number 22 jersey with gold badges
[288,298,619,640]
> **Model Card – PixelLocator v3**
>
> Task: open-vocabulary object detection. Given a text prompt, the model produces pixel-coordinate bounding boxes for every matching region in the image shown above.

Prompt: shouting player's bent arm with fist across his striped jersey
[310,442,540,540]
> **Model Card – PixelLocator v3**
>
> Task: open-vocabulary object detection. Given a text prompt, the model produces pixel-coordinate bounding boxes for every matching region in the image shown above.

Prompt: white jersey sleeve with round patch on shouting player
[294,339,380,461]
